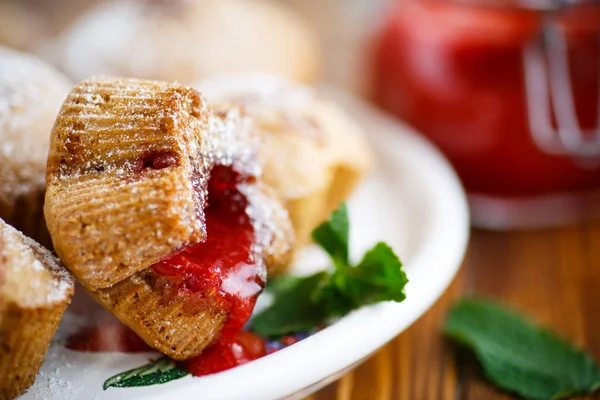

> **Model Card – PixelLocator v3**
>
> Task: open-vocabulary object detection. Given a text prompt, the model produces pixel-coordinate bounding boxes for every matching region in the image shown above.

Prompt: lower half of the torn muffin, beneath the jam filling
[90,179,293,360]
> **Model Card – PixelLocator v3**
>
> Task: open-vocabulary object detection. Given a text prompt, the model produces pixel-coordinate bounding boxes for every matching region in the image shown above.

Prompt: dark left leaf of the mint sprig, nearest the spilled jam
[251,272,328,337]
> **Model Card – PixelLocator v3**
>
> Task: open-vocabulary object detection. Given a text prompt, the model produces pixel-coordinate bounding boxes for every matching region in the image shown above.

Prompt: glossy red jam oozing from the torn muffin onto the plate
[152,166,266,376]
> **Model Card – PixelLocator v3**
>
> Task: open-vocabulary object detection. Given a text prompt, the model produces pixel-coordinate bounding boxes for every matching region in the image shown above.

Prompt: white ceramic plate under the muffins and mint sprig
[24,76,469,400]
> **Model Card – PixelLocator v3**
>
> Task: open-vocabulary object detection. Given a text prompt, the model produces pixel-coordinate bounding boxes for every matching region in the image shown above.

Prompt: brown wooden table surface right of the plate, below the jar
[308,224,600,400]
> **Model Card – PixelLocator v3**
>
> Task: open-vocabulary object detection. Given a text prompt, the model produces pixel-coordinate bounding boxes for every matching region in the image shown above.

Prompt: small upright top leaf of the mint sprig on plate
[312,203,350,266]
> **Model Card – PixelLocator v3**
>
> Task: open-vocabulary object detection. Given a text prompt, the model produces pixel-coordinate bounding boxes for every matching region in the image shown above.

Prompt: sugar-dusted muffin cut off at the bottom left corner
[0,219,73,399]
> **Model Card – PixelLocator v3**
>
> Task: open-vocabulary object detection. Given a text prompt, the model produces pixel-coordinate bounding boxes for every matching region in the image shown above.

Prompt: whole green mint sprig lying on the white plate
[251,204,408,337]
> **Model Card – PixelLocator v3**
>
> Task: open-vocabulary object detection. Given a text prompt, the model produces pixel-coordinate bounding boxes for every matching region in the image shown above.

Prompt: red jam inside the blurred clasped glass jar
[373,0,600,196]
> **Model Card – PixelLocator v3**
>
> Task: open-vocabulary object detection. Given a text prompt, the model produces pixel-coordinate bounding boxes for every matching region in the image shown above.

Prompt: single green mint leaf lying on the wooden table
[444,299,600,400]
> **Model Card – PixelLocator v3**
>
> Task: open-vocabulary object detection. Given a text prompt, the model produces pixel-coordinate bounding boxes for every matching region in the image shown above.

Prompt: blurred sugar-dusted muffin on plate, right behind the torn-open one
[197,75,373,244]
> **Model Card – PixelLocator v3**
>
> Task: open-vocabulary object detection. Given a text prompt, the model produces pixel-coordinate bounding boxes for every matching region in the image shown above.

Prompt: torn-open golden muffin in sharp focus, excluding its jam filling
[45,78,293,360]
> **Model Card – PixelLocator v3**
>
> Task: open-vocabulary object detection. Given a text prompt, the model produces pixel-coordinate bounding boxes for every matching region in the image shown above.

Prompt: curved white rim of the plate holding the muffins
[28,74,470,400]
